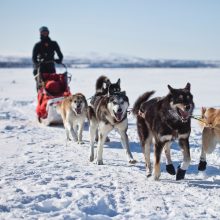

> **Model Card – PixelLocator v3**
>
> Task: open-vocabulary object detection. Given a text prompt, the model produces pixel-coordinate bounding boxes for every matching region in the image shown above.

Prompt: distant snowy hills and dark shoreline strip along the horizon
[0,54,220,68]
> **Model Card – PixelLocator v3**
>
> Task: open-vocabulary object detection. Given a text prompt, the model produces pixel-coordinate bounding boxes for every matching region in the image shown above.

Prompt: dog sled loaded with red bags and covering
[36,61,71,125]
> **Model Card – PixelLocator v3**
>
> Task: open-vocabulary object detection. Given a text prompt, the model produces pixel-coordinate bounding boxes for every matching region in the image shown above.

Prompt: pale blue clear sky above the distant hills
[0,0,220,60]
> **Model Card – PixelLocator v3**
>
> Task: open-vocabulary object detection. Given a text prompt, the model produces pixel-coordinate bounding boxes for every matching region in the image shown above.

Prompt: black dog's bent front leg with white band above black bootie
[176,139,191,180]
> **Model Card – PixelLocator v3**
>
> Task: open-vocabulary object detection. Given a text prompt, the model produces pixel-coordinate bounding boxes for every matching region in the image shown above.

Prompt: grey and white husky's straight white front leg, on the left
[96,122,112,165]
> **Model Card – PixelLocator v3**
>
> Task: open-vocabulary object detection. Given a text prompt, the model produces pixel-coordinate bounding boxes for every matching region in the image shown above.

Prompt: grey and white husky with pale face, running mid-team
[88,92,136,165]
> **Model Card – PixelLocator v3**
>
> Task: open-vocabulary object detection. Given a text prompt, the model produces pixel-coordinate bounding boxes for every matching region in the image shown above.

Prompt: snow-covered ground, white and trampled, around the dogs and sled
[0,69,220,220]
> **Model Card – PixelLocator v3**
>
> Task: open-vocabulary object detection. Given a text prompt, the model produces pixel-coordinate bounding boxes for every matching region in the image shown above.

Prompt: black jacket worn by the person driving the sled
[32,37,63,66]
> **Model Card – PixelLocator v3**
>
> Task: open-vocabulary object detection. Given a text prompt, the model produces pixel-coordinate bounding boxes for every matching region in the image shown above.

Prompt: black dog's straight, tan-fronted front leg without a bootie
[154,142,164,180]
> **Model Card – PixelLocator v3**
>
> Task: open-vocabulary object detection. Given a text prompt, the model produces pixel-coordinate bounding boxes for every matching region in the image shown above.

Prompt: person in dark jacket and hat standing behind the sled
[32,26,63,76]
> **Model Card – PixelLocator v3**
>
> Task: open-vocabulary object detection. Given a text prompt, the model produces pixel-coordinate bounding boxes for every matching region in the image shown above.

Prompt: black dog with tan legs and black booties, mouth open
[133,83,194,180]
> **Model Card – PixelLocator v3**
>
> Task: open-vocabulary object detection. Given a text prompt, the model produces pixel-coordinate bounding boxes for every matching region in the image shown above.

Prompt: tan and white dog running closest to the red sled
[57,93,88,143]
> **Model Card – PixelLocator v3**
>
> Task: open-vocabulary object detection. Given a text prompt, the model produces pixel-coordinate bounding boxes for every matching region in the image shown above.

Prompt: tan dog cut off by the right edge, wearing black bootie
[198,108,220,171]
